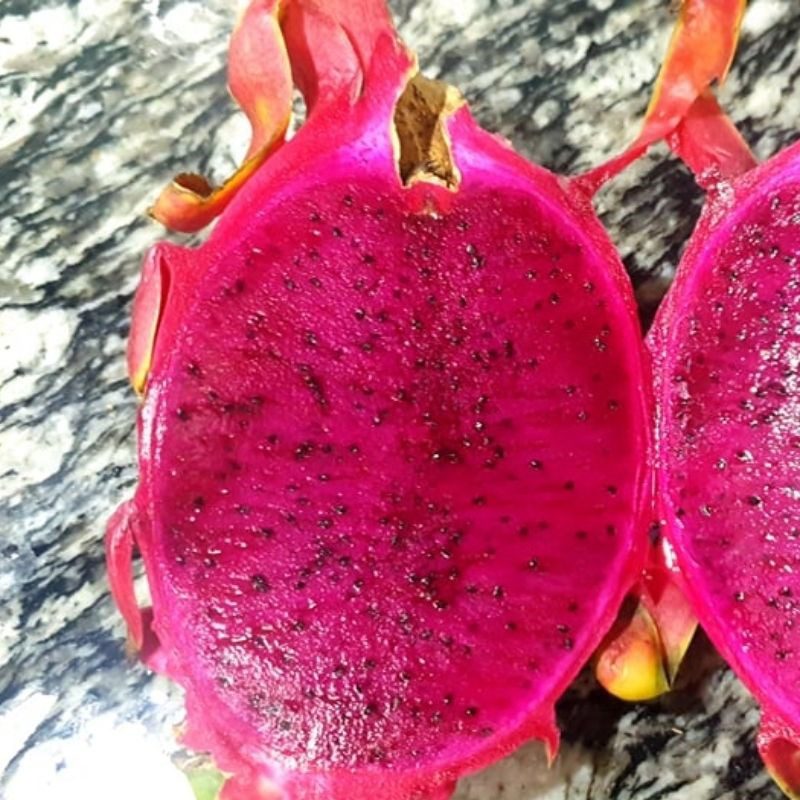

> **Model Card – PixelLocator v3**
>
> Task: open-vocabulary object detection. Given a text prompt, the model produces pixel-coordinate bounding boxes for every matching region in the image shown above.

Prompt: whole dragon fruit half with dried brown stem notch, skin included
[107,0,650,800]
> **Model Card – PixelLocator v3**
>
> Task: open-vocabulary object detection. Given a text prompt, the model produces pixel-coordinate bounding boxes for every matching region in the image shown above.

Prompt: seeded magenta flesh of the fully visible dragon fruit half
[149,173,644,769]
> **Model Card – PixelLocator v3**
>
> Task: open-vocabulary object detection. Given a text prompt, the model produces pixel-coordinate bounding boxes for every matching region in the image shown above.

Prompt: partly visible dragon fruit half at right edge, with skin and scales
[590,0,800,797]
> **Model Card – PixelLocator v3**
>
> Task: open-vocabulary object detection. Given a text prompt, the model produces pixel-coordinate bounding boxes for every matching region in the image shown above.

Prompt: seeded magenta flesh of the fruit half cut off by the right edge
[662,182,800,710]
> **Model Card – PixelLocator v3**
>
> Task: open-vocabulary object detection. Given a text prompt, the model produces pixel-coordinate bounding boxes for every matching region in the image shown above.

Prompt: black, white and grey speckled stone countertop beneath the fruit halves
[0,0,800,800]
